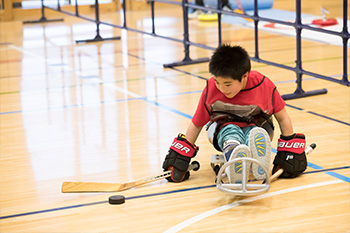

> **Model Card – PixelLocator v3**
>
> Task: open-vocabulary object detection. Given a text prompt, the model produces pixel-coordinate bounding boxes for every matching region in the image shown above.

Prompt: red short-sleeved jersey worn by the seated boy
[192,71,286,127]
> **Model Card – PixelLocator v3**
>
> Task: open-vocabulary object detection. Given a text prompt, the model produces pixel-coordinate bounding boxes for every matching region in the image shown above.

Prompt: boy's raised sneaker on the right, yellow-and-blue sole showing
[249,127,271,180]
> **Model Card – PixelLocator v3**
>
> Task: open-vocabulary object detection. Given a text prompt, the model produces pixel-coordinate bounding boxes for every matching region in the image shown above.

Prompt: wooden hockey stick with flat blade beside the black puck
[62,161,199,193]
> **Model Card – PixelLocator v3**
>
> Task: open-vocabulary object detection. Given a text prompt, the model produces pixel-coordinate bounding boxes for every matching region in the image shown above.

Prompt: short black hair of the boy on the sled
[209,44,251,82]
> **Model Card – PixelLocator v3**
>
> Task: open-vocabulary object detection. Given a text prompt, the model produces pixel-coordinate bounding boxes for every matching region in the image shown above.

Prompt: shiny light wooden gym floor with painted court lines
[0,0,350,232]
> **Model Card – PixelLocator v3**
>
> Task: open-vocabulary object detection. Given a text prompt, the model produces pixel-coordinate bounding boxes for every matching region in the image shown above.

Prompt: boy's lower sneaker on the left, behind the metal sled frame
[225,145,251,184]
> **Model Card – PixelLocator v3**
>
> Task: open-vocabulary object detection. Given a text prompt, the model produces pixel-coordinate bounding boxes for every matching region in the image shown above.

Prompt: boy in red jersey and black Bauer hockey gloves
[163,45,307,183]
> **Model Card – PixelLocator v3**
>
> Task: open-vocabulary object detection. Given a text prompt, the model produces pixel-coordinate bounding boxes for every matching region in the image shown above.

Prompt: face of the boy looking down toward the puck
[214,75,248,98]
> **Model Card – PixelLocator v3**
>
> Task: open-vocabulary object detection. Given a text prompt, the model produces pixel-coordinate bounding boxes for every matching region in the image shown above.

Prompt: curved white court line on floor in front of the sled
[164,180,343,233]
